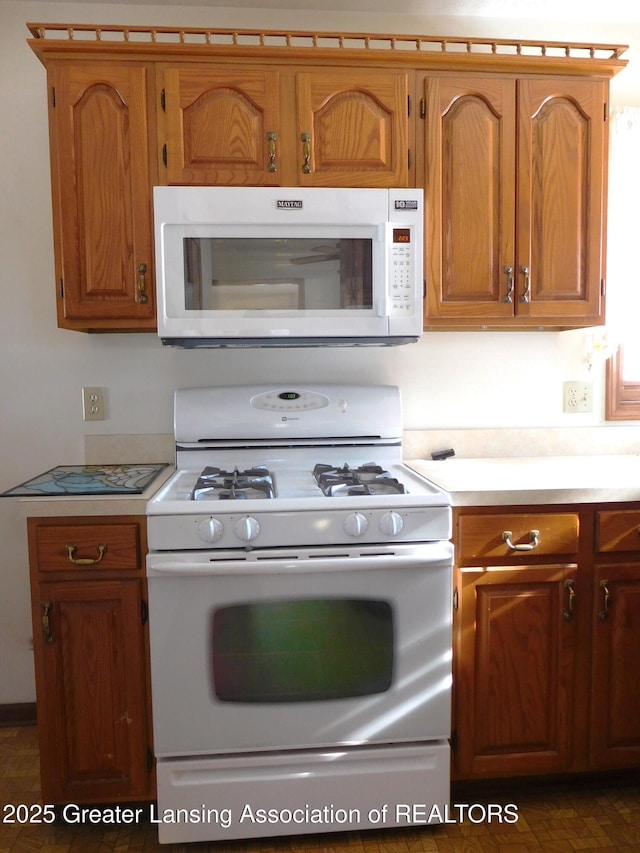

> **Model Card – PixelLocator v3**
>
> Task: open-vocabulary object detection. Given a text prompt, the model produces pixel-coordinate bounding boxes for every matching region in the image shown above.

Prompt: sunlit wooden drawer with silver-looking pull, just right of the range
[458,513,579,563]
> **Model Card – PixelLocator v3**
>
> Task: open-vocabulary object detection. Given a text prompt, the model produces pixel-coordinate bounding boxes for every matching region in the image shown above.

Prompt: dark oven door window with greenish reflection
[211,598,394,703]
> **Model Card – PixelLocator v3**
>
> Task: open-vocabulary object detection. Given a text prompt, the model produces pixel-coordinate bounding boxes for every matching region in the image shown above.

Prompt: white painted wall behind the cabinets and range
[0,0,640,704]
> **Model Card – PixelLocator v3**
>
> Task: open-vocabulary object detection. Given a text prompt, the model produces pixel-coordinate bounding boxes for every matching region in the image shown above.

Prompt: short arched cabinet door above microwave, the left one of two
[163,66,280,186]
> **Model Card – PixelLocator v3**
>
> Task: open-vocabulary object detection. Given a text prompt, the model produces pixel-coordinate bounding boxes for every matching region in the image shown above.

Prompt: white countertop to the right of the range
[405,455,640,506]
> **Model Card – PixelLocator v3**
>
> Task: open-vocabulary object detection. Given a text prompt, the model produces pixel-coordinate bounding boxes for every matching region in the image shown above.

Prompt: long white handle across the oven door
[147,542,453,578]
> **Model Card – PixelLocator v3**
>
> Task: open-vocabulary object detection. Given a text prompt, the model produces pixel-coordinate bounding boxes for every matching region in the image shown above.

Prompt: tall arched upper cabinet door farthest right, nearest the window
[516,80,606,320]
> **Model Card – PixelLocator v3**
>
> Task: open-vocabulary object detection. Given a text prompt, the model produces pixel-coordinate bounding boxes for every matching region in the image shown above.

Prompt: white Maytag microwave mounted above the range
[154,186,423,347]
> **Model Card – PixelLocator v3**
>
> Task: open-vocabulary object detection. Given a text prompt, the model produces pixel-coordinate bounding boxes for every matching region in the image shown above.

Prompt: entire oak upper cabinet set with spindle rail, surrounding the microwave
[27,23,626,331]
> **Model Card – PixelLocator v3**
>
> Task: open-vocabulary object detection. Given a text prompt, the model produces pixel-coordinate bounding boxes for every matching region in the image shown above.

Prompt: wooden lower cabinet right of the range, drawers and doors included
[452,505,640,779]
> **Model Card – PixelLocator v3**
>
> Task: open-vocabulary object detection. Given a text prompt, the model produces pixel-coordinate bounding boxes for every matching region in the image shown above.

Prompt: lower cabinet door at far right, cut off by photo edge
[591,564,640,769]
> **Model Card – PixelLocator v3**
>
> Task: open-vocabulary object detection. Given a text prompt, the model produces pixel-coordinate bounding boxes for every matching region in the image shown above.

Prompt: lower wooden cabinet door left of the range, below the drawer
[34,580,149,803]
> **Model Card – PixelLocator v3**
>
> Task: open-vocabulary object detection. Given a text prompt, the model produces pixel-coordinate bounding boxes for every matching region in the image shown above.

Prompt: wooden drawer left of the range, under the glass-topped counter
[34,522,141,572]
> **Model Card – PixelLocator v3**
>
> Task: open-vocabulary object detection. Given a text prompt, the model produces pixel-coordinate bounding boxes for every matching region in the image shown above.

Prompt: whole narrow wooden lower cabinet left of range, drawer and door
[28,517,154,804]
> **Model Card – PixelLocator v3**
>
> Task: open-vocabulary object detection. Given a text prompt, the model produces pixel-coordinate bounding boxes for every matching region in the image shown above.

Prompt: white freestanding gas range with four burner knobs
[147,384,453,842]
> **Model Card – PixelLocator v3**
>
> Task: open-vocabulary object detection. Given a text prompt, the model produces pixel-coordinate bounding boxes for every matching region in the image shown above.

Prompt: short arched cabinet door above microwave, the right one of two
[296,69,410,187]
